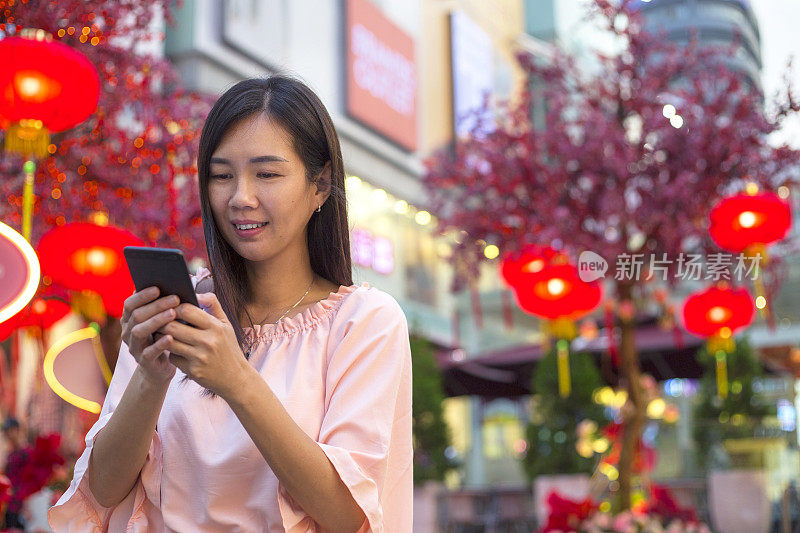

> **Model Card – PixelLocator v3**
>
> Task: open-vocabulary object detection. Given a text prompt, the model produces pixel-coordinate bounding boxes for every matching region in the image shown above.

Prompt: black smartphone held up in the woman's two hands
[122,246,200,307]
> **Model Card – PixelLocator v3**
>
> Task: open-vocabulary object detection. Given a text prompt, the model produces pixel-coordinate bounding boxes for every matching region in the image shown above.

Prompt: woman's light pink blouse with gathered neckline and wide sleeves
[48,271,413,533]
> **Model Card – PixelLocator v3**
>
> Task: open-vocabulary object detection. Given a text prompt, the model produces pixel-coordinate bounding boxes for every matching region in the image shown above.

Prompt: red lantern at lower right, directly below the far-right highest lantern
[683,287,755,338]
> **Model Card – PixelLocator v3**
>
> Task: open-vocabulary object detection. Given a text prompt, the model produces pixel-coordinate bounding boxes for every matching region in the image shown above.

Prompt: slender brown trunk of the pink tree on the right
[614,282,647,512]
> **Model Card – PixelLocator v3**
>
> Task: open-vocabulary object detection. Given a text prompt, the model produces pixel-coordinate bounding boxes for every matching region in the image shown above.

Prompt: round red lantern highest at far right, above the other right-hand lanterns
[709,192,792,252]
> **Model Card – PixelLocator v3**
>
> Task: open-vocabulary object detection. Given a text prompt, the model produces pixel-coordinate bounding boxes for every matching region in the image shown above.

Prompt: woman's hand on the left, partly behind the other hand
[121,287,180,385]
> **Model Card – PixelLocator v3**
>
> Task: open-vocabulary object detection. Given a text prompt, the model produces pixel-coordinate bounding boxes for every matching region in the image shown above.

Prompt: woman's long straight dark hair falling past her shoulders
[197,75,353,346]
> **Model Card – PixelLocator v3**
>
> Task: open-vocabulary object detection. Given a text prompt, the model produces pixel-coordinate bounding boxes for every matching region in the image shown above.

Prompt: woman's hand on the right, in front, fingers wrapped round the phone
[160,292,249,398]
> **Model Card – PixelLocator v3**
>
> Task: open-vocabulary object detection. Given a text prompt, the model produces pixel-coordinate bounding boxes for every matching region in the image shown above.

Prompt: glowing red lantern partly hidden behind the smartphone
[36,222,144,317]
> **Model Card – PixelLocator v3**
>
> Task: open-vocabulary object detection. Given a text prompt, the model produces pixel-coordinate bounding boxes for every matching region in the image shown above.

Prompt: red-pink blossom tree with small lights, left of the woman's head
[0,0,210,257]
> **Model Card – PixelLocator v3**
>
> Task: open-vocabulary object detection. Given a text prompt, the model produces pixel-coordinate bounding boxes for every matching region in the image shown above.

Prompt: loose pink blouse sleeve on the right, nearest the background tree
[278,288,413,533]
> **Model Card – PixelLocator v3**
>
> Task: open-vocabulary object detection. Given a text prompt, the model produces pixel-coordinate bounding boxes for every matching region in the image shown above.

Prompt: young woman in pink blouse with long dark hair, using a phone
[49,76,412,532]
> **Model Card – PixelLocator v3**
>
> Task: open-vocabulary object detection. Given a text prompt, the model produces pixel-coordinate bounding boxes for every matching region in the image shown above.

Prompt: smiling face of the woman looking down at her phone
[208,114,326,262]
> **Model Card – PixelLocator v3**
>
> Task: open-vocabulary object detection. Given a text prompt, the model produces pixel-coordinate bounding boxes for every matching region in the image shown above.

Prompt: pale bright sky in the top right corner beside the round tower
[750,0,800,148]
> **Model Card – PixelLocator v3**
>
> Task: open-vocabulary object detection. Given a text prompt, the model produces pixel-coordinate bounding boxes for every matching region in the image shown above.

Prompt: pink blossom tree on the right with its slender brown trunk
[424,0,800,509]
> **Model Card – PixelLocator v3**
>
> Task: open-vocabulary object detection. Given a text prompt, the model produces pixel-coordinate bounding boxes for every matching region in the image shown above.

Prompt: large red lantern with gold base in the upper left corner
[0,30,100,155]
